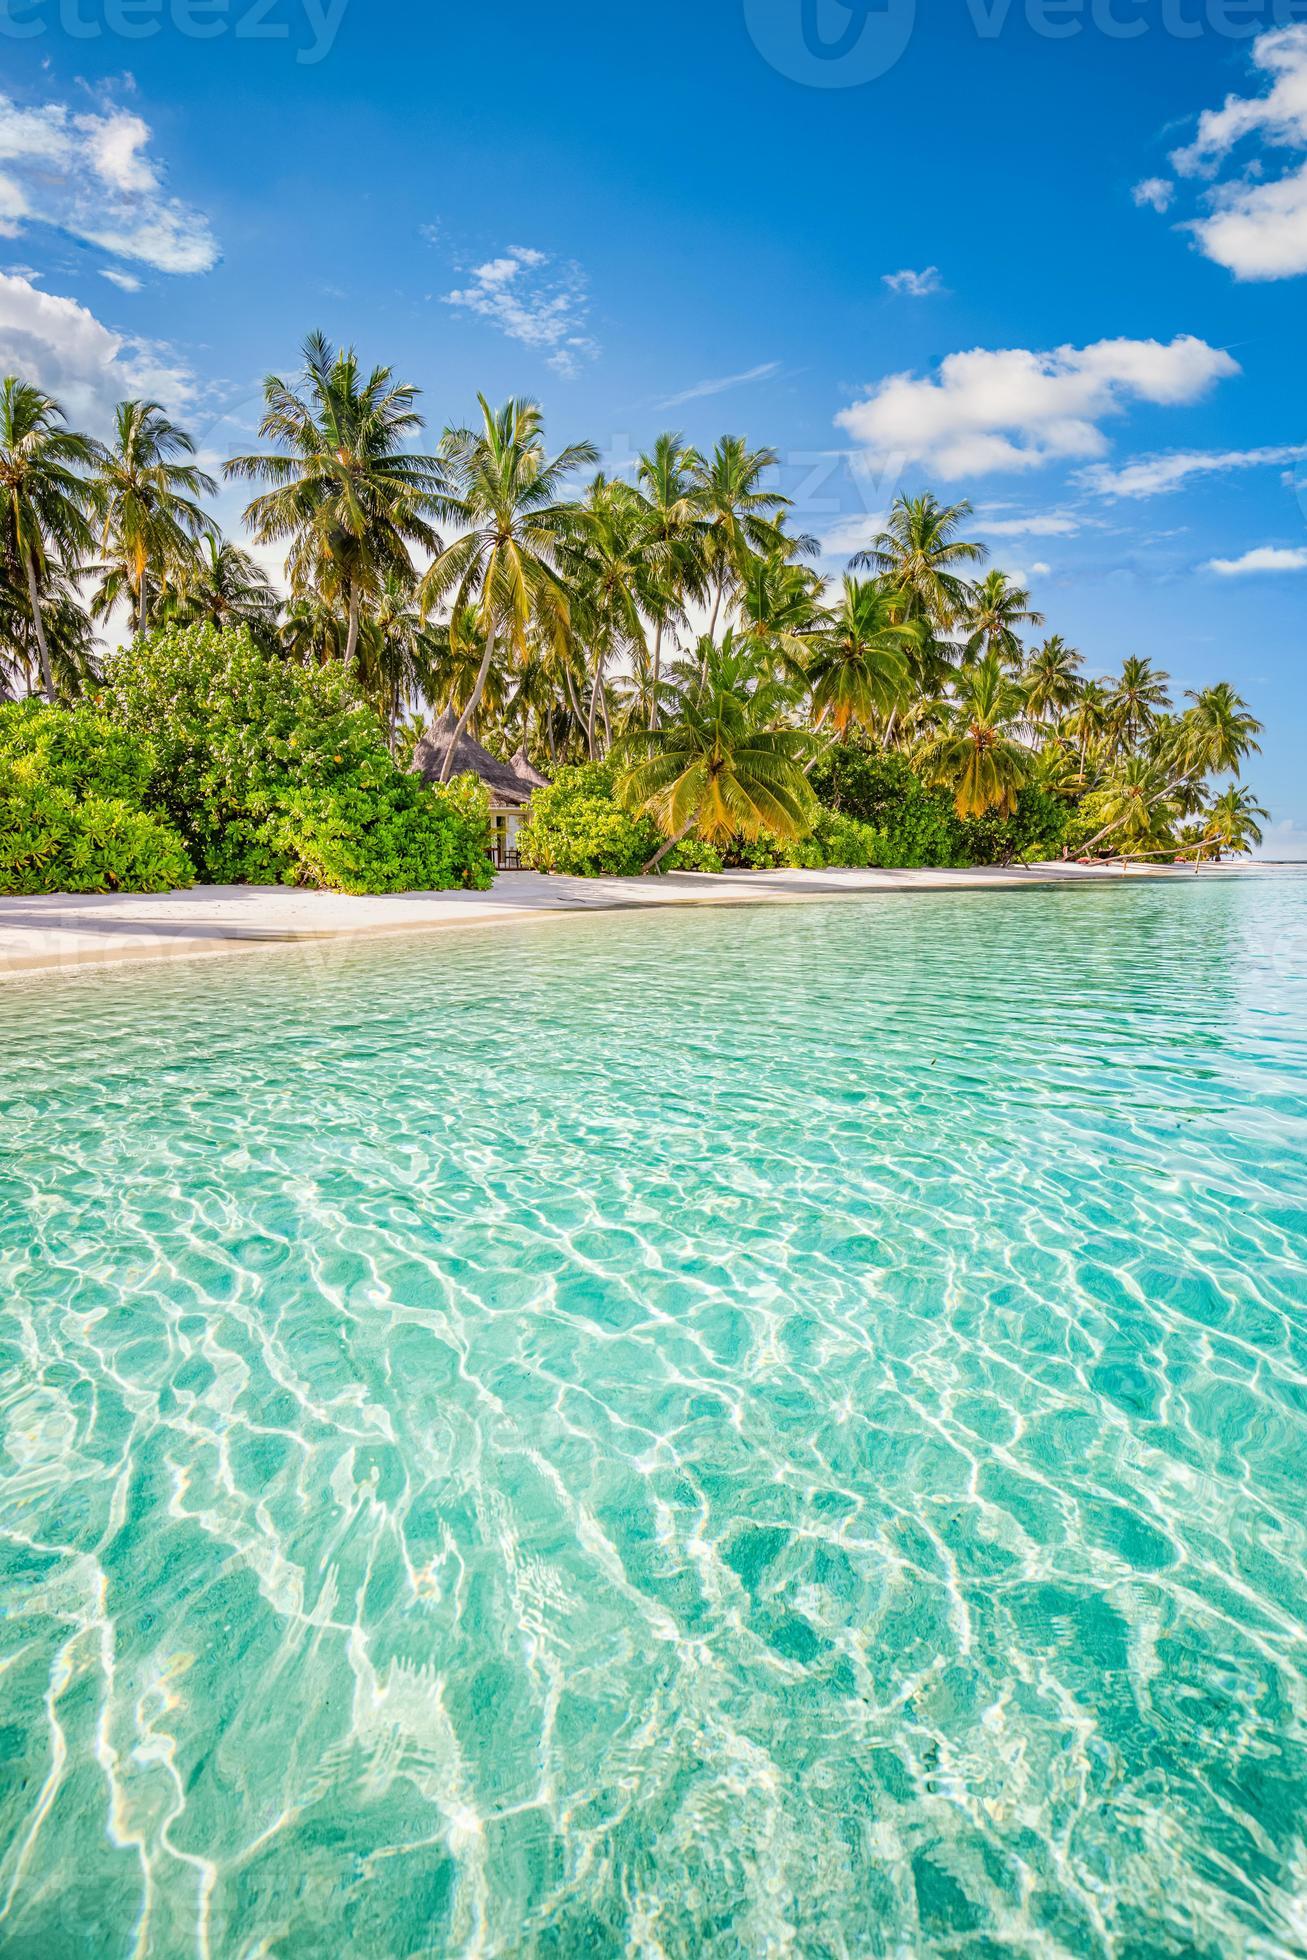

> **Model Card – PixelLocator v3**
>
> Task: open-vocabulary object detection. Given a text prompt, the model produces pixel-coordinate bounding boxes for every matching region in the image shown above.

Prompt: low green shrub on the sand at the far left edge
[0,756,196,896]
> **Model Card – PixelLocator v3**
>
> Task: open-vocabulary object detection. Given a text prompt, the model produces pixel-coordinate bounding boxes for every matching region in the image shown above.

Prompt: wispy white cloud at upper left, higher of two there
[0,94,218,272]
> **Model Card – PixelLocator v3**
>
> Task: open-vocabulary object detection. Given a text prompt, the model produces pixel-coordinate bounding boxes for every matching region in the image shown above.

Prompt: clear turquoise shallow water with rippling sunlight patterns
[0,876,1307,1960]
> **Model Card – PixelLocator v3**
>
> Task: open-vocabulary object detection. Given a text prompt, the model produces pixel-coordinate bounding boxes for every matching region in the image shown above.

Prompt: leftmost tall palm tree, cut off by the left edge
[0,374,96,702]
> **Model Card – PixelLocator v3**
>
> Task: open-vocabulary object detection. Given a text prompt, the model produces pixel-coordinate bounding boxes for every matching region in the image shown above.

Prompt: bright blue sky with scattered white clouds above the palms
[0,0,1307,855]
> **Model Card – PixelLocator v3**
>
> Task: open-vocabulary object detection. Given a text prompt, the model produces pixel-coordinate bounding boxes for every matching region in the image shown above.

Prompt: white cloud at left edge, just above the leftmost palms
[0,272,196,433]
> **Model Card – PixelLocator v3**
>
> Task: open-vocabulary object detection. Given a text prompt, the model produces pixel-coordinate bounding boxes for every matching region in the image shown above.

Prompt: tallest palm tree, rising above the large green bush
[225,333,449,664]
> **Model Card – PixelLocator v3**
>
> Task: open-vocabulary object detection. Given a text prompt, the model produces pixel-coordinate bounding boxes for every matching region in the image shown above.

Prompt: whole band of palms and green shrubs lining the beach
[0,344,1266,890]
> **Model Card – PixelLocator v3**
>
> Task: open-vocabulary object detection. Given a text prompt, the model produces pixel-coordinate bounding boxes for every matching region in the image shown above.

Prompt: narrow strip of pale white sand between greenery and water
[0,864,1219,980]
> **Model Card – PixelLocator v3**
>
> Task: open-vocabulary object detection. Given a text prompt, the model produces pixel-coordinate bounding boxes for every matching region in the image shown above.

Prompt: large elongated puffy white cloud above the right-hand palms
[835,333,1238,478]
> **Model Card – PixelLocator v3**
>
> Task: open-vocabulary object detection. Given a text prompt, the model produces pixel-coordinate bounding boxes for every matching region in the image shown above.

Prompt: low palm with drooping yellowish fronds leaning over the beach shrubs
[617,631,817,872]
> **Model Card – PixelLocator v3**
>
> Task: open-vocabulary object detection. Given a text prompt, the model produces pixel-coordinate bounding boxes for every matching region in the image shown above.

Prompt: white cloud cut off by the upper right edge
[1172,24,1307,280]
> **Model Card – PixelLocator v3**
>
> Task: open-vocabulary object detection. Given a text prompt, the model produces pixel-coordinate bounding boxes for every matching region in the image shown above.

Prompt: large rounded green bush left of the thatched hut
[106,625,492,892]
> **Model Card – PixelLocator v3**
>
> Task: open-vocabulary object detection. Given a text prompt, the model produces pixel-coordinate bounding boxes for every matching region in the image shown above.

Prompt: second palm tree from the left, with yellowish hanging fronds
[94,402,218,633]
